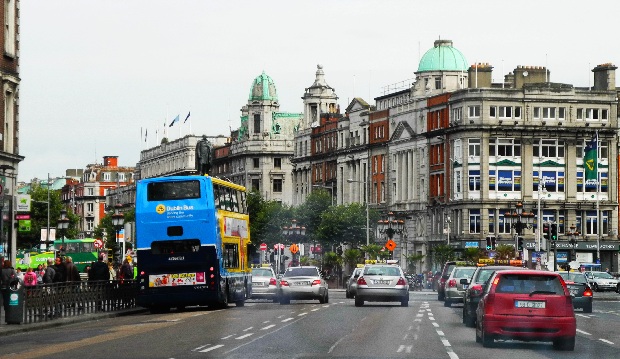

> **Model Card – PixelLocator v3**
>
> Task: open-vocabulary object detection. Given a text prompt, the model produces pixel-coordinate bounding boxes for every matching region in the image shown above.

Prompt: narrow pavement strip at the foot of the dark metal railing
[0,307,147,337]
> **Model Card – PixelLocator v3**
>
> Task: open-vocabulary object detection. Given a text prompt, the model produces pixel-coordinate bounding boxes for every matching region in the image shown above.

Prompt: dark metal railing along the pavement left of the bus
[23,280,138,324]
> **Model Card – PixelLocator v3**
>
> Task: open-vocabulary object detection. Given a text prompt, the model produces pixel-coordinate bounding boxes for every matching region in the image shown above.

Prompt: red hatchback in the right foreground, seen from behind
[476,270,577,350]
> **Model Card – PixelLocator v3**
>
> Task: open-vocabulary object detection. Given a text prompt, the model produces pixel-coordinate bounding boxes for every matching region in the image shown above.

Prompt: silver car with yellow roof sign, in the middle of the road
[355,264,409,307]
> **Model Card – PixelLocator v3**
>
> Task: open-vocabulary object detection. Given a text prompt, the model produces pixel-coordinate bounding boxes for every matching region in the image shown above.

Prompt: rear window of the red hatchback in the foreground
[495,274,564,295]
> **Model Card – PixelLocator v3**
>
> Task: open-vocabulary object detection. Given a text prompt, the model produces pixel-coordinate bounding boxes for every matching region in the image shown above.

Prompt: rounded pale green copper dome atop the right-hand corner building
[418,40,468,72]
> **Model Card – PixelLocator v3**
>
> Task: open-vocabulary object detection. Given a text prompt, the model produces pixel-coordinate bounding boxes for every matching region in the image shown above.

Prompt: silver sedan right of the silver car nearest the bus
[280,266,329,304]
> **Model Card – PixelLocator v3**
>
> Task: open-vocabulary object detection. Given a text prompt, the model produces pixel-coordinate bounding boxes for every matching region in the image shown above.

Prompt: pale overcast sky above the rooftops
[19,0,620,181]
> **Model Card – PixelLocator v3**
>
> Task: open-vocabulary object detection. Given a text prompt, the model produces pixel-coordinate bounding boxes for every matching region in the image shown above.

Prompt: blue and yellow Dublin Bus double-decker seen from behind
[136,176,252,312]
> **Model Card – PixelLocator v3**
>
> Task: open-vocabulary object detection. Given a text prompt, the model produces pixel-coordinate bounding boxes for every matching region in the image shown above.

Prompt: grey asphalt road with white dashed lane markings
[0,291,620,359]
